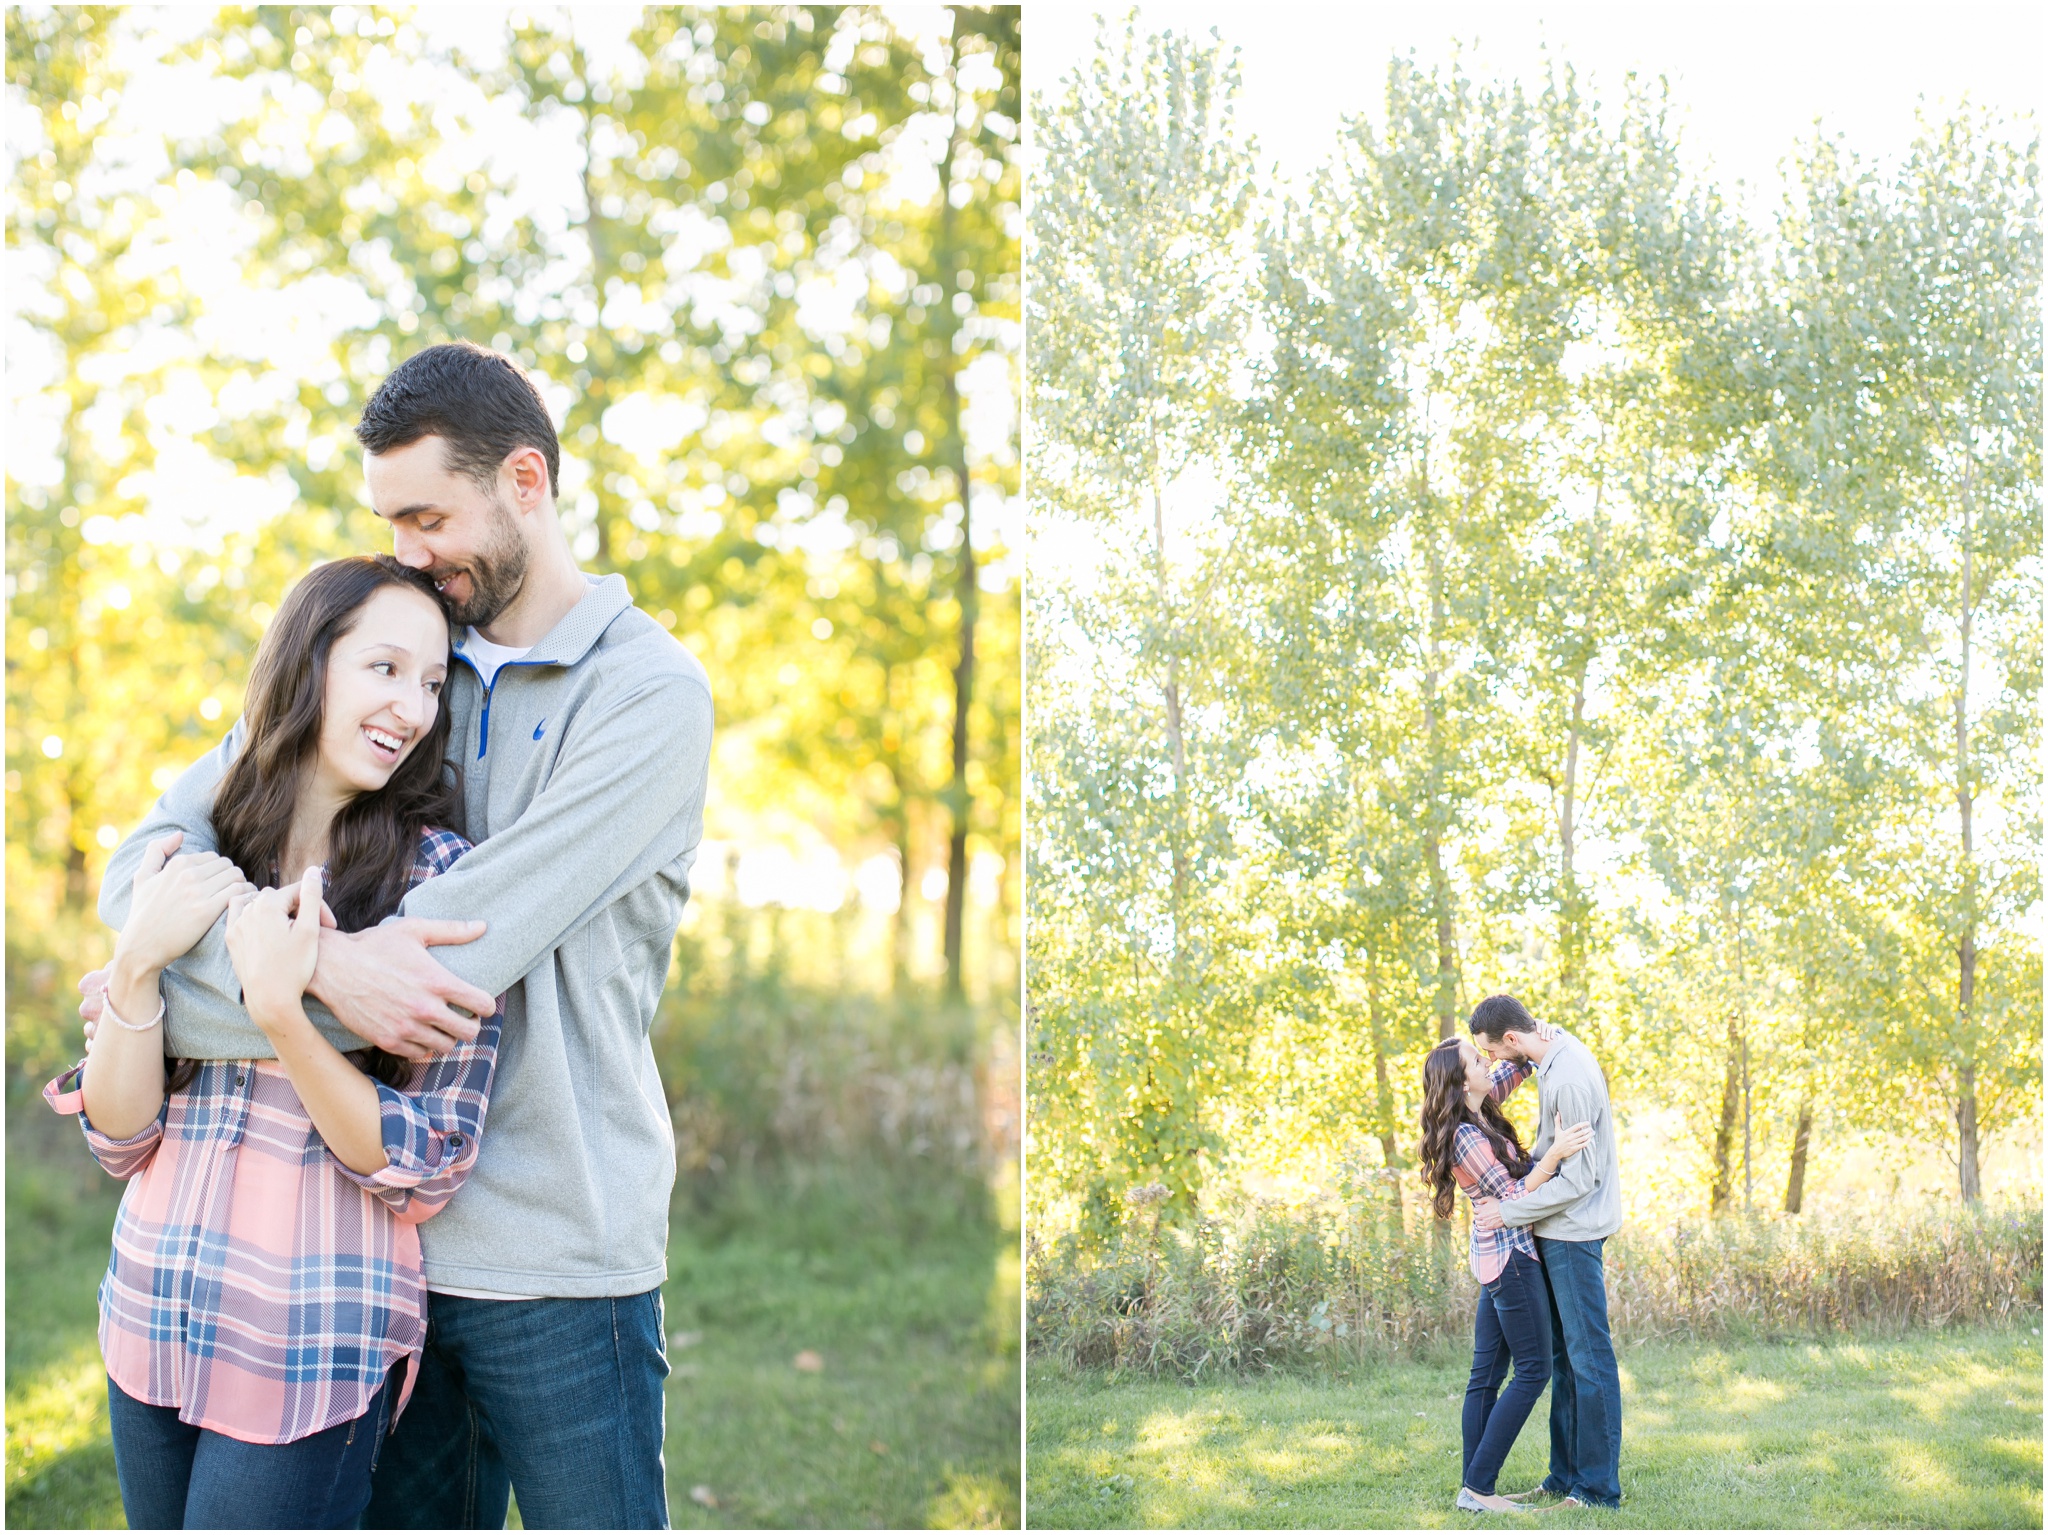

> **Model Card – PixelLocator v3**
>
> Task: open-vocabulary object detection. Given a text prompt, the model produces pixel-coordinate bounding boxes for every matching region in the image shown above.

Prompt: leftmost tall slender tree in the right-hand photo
[1026,16,1251,1216]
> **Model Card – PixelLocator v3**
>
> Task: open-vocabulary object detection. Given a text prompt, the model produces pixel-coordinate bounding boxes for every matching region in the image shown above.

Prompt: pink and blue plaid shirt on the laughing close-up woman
[43,831,498,1445]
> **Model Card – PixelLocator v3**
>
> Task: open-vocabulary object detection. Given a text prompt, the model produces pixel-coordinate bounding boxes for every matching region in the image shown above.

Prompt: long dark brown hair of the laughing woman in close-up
[168,555,461,1091]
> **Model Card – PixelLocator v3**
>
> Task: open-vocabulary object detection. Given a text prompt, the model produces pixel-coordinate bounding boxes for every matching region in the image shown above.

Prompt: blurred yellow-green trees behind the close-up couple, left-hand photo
[6,6,1022,1523]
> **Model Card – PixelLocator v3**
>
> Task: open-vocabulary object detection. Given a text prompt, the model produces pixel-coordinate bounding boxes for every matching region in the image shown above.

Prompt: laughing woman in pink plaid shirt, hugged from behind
[45,555,498,1529]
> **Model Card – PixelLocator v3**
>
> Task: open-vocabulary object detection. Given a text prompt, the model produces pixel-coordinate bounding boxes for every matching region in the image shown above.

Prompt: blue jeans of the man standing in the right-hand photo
[1536,1236,1622,1508]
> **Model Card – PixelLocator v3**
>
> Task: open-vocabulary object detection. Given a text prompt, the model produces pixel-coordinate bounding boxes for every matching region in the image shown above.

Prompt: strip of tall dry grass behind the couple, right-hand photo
[1026,1201,2042,1379]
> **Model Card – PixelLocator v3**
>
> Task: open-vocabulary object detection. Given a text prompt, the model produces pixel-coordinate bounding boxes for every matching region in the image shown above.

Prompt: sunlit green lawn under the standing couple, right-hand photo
[1028,1324,2042,1529]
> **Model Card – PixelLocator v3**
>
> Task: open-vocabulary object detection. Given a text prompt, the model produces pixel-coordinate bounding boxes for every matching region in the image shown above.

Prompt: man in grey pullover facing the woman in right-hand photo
[1468,997,1622,1508]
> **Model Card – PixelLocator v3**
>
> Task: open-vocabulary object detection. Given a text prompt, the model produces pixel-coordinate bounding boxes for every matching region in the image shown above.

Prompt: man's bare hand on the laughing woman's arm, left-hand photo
[307,917,498,1060]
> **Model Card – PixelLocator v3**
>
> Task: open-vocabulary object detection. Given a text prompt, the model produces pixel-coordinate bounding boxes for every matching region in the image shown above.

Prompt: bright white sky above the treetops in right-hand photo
[1024,0,2048,201]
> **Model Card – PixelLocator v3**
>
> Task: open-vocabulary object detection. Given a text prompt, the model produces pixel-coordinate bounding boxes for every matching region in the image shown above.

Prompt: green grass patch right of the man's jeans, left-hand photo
[668,1175,1018,1529]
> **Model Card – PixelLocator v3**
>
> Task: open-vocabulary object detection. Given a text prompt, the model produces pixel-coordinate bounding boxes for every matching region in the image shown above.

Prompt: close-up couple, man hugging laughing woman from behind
[45,344,713,1529]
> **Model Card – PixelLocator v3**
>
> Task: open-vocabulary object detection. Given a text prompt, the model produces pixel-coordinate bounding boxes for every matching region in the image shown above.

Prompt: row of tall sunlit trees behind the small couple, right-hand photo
[1026,25,2042,1238]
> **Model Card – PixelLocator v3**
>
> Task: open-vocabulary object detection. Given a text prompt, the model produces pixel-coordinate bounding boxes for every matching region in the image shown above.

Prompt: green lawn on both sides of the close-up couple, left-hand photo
[6,1099,1018,1529]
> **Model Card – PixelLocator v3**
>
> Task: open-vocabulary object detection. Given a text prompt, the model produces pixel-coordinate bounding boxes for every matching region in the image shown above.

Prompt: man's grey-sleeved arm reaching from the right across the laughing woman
[313,673,713,1034]
